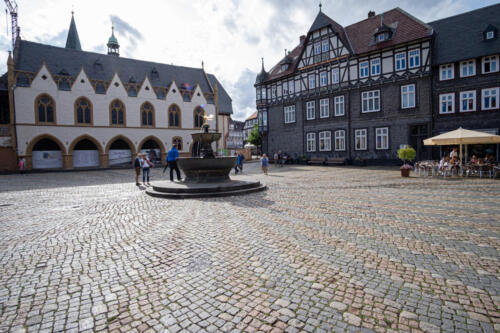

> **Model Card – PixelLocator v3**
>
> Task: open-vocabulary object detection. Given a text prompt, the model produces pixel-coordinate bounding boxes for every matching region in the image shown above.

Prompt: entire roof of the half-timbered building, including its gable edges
[256,8,432,84]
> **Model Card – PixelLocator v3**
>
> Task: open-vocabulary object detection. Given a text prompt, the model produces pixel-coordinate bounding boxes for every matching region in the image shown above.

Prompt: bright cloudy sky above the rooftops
[0,0,498,120]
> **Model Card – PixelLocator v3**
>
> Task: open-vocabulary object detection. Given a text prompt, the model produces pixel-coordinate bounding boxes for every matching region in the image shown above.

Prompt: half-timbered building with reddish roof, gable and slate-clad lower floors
[255,8,432,161]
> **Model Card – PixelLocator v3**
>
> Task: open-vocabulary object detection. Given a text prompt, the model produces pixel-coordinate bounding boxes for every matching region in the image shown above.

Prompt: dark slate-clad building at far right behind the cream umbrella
[429,4,500,160]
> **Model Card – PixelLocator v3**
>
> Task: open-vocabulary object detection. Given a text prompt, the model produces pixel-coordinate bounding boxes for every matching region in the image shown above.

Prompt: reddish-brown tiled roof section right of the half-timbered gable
[345,8,432,54]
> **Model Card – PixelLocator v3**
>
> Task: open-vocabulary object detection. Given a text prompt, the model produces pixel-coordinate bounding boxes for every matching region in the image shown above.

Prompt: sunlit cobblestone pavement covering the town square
[0,163,500,332]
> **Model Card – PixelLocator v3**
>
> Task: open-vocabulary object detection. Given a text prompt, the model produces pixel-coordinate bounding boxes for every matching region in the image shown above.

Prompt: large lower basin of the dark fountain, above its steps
[177,156,236,183]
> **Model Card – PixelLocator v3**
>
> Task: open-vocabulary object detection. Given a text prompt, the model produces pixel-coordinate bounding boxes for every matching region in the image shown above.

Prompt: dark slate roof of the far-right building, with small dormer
[429,4,500,65]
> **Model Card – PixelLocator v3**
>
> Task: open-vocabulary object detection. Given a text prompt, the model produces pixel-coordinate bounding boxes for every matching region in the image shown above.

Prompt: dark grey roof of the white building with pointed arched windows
[14,40,233,114]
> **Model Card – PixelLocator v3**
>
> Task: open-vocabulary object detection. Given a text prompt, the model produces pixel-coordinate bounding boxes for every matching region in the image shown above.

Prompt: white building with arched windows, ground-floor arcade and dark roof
[0,13,232,169]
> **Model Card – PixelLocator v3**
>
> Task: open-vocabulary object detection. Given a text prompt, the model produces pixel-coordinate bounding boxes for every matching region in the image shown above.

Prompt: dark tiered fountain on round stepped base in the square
[146,122,266,199]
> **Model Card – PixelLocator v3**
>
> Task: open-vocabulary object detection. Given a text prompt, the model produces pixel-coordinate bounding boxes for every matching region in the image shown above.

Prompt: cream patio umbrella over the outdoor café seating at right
[424,127,500,161]
